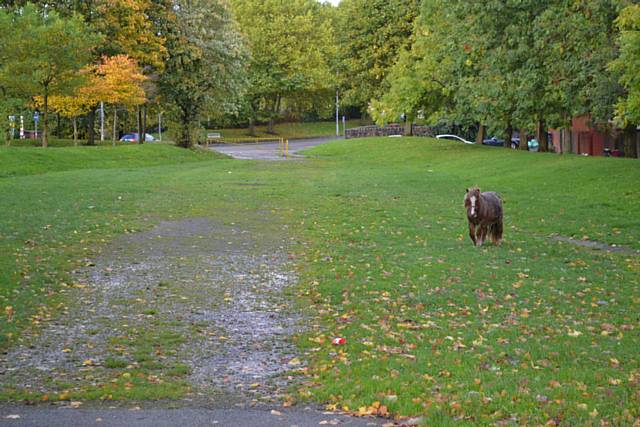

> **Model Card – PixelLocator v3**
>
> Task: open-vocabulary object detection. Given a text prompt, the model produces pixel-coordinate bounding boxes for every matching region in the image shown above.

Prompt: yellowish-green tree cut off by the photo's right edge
[610,4,640,157]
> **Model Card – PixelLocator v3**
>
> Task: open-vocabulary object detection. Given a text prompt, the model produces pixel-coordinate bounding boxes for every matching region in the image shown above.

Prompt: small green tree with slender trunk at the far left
[0,3,99,147]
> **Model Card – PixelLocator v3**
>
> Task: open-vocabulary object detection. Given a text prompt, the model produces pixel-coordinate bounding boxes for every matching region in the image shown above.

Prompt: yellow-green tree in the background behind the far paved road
[231,0,335,133]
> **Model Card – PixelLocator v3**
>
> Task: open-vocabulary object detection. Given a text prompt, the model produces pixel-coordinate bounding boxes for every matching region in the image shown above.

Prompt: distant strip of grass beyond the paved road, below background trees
[213,120,370,140]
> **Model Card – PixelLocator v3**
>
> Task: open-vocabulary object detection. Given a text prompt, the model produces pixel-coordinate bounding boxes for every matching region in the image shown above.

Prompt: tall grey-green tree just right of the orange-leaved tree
[160,0,246,147]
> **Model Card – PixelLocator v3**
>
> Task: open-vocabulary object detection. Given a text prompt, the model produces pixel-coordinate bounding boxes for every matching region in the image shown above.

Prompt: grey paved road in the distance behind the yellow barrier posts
[209,137,342,160]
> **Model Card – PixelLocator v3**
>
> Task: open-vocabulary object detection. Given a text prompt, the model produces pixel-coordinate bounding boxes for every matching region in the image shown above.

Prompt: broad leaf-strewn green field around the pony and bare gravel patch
[0,138,640,425]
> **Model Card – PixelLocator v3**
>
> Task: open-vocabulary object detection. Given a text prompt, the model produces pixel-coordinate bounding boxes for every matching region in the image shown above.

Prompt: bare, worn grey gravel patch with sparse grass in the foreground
[0,218,300,407]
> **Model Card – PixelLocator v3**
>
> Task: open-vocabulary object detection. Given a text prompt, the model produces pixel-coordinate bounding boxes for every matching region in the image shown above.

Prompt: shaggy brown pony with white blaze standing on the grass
[464,188,502,246]
